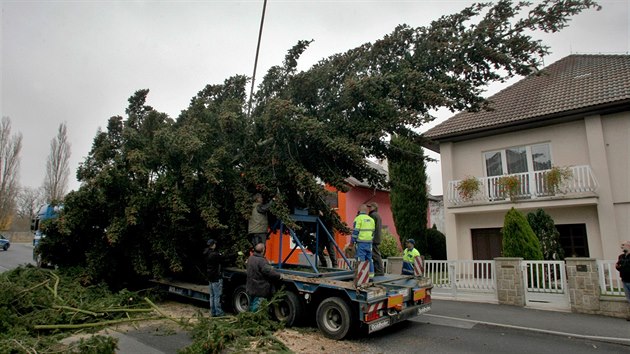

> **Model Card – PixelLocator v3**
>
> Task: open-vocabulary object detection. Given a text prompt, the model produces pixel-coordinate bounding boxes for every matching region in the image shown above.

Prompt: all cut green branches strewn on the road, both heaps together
[0,266,289,354]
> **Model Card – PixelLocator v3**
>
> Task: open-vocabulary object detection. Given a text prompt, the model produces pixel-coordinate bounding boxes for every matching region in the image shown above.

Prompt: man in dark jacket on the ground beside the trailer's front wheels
[245,243,282,312]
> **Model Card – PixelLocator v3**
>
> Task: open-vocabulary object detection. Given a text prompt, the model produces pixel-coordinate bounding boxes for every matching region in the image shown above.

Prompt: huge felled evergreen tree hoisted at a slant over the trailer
[42,0,596,282]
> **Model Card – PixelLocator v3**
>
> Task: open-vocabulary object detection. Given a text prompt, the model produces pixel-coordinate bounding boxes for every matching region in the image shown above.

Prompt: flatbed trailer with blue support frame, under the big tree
[154,215,433,340]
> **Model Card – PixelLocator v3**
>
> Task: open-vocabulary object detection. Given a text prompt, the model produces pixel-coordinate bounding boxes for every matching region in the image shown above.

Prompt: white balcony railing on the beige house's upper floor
[446,165,598,206]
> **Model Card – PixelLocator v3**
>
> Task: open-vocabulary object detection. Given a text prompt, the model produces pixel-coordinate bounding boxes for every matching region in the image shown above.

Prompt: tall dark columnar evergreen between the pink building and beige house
[388,136,428,255]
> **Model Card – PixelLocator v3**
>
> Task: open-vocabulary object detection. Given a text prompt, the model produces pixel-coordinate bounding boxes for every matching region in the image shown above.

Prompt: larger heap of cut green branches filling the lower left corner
[0,266,162,353]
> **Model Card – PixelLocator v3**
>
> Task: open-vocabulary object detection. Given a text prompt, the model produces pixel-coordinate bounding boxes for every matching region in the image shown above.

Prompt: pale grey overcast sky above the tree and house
[0,0,630,195]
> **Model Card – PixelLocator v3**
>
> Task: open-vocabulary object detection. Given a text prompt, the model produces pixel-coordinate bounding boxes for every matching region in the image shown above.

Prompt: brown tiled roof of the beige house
[424,54,630,145]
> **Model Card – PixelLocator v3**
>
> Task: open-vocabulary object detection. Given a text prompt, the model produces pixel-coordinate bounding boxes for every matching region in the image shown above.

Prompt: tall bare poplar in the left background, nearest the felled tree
[43,122,70,202]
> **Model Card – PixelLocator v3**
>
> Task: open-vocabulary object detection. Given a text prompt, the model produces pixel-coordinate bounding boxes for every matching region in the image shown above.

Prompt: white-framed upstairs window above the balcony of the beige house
[484,143,551,177]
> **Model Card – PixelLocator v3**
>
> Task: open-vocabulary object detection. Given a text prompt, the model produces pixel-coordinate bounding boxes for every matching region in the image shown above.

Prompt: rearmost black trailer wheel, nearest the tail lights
[316,297,354,340]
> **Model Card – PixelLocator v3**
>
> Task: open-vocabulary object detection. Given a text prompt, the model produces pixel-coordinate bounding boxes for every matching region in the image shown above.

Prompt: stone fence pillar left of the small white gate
[494,257,525,306]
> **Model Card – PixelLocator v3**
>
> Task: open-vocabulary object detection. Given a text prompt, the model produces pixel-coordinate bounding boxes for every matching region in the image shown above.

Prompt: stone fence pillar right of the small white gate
[565,257,600,314]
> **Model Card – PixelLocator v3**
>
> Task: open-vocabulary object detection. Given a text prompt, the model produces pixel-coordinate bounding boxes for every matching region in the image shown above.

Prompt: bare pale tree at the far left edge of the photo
[0,117,22,230]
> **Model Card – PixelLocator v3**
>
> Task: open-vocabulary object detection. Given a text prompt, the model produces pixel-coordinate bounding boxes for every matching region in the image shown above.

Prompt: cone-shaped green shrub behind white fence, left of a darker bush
[501,208,543,260]
